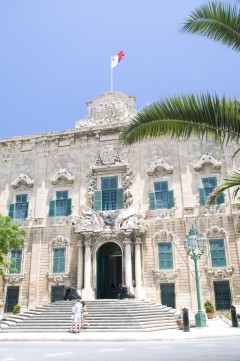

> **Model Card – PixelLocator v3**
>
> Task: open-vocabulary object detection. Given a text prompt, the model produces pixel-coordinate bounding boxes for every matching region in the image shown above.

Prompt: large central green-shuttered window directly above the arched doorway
[94,177,124,211]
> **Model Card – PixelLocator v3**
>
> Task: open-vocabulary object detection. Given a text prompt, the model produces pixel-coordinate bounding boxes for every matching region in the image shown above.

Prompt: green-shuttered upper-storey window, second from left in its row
[49,191,72,217]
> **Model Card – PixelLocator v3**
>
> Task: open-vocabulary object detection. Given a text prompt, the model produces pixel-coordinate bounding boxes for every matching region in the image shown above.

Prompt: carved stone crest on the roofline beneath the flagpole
[76,92,136,128]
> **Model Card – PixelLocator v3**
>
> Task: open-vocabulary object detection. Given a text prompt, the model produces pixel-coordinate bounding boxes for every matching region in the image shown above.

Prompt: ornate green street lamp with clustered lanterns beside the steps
[184,225,206,327]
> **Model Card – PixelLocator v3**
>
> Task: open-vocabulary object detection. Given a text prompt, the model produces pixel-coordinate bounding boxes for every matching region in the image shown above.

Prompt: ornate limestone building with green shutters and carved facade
[0,92,240,311]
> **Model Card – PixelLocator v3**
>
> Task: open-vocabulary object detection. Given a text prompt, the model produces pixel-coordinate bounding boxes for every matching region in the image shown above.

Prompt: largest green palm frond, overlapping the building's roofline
[121,93,240,144]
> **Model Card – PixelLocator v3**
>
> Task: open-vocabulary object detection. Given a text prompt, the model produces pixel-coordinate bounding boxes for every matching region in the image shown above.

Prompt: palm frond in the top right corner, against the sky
[181,2,240,52]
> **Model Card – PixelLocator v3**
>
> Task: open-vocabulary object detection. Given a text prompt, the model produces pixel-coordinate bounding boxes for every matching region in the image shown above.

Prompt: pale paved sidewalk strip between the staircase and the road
[0,318,240,342]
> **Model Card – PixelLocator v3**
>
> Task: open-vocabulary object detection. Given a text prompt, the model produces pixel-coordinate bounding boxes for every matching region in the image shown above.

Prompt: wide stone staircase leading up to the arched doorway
[1,300,177,332]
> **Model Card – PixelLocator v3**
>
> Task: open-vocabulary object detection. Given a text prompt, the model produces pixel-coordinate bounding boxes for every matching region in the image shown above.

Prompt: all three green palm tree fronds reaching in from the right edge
[121,3,240,205]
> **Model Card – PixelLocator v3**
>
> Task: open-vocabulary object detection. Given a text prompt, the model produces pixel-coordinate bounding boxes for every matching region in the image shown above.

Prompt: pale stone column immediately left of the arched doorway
[82,235,94,300]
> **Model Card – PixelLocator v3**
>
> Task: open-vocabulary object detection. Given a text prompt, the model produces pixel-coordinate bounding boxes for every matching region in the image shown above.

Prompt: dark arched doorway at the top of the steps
[97,242,122,299]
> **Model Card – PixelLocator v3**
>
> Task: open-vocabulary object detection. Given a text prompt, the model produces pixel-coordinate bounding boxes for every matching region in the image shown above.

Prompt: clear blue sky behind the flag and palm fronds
[0,0,240,138]
